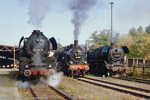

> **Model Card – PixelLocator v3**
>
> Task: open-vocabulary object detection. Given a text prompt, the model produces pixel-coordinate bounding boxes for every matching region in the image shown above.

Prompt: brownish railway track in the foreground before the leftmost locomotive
[30,86,73,100]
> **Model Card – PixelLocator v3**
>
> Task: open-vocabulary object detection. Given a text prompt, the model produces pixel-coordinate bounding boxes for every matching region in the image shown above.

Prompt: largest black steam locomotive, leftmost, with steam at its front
[18,30,57,81]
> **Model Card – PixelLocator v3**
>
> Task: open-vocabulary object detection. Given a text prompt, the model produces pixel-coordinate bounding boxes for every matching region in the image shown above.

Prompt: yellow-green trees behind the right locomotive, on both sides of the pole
[87,25,150,59]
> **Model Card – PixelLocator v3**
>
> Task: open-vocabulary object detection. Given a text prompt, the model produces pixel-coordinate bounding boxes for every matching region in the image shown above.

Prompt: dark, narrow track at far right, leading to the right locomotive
[113,77,150,84]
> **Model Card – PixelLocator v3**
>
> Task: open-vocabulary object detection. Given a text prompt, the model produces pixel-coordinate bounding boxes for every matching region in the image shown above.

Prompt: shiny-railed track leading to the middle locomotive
[78,77,150,99]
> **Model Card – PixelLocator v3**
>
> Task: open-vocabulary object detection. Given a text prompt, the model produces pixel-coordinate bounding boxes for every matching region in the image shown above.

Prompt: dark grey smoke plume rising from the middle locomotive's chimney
[69,0,97,40]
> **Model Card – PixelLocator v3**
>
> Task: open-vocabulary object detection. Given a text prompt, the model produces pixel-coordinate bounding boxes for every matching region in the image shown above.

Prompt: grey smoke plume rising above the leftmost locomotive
[28,0,51,29]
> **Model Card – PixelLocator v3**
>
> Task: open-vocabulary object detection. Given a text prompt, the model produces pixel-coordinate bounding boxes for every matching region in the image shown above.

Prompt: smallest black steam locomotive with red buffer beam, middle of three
[55,40,89,76]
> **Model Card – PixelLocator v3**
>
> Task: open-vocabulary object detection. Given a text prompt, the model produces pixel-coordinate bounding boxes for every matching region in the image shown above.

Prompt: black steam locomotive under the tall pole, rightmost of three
[87,44,129,76]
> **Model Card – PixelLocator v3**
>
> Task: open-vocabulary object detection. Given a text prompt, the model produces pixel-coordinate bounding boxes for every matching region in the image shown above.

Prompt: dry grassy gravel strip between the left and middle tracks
[58,77,146,100]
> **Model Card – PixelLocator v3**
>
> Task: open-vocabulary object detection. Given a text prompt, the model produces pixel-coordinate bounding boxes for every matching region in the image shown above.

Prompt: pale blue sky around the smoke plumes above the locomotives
[0,0,150,46]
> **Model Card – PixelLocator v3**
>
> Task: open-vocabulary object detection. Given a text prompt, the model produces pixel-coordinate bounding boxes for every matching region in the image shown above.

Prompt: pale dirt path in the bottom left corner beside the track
[0,71,21,100]
